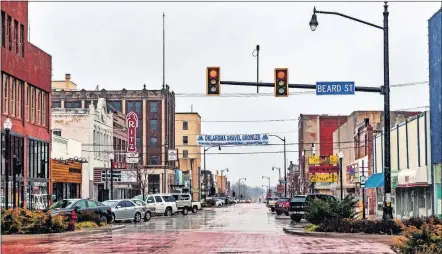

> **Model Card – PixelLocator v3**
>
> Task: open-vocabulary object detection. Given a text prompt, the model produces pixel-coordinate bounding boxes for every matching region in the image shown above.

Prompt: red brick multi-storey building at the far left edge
[1,1,52,209]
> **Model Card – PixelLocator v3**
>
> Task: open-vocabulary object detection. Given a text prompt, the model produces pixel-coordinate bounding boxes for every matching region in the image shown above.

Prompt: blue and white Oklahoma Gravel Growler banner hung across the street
[196,134,269,146]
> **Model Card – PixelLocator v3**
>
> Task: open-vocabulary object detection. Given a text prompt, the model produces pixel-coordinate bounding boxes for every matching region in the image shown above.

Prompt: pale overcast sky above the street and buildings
[29,2,441,189]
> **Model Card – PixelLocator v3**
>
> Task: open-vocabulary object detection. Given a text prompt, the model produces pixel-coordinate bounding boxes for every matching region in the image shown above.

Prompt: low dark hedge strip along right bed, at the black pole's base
[316,217,402,235]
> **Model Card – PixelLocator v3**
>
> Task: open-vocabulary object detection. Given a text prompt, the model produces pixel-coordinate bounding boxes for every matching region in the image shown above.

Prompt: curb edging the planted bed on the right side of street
[282,228,396,242]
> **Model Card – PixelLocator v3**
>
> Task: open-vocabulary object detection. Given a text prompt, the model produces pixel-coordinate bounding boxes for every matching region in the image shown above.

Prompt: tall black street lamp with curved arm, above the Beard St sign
[309,2,393,220]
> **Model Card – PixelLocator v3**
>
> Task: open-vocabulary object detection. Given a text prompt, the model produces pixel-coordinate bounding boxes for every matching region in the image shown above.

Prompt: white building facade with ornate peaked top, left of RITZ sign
[51,98,113,200]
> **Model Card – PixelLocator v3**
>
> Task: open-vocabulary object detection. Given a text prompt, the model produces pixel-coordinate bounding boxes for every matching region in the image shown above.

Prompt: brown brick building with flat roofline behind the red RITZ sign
[52,75,175,192]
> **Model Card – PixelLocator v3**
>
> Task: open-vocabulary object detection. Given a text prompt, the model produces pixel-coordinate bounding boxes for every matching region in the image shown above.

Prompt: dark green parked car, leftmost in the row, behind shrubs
[48,199,112,223]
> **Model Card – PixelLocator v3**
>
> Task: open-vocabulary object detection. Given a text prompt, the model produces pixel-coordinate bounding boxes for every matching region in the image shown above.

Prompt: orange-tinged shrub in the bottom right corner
[392,218,442,254]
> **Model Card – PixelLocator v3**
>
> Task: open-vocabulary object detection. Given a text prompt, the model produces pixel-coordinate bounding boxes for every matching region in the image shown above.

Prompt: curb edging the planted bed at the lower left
[1,225,126,242]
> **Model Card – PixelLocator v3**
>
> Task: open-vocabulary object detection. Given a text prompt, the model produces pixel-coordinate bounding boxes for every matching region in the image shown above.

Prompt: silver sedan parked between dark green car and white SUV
[103,199,144,222]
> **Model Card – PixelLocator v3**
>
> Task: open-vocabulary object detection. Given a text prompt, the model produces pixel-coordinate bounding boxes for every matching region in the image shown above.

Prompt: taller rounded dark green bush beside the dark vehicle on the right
[305,196,358,225]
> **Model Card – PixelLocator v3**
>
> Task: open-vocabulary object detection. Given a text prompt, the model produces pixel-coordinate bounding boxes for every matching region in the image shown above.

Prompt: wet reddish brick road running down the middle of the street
[2,204,392,254]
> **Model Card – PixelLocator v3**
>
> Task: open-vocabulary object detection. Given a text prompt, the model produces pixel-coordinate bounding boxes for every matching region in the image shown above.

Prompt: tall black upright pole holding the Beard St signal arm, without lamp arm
[383,2,393,220]
